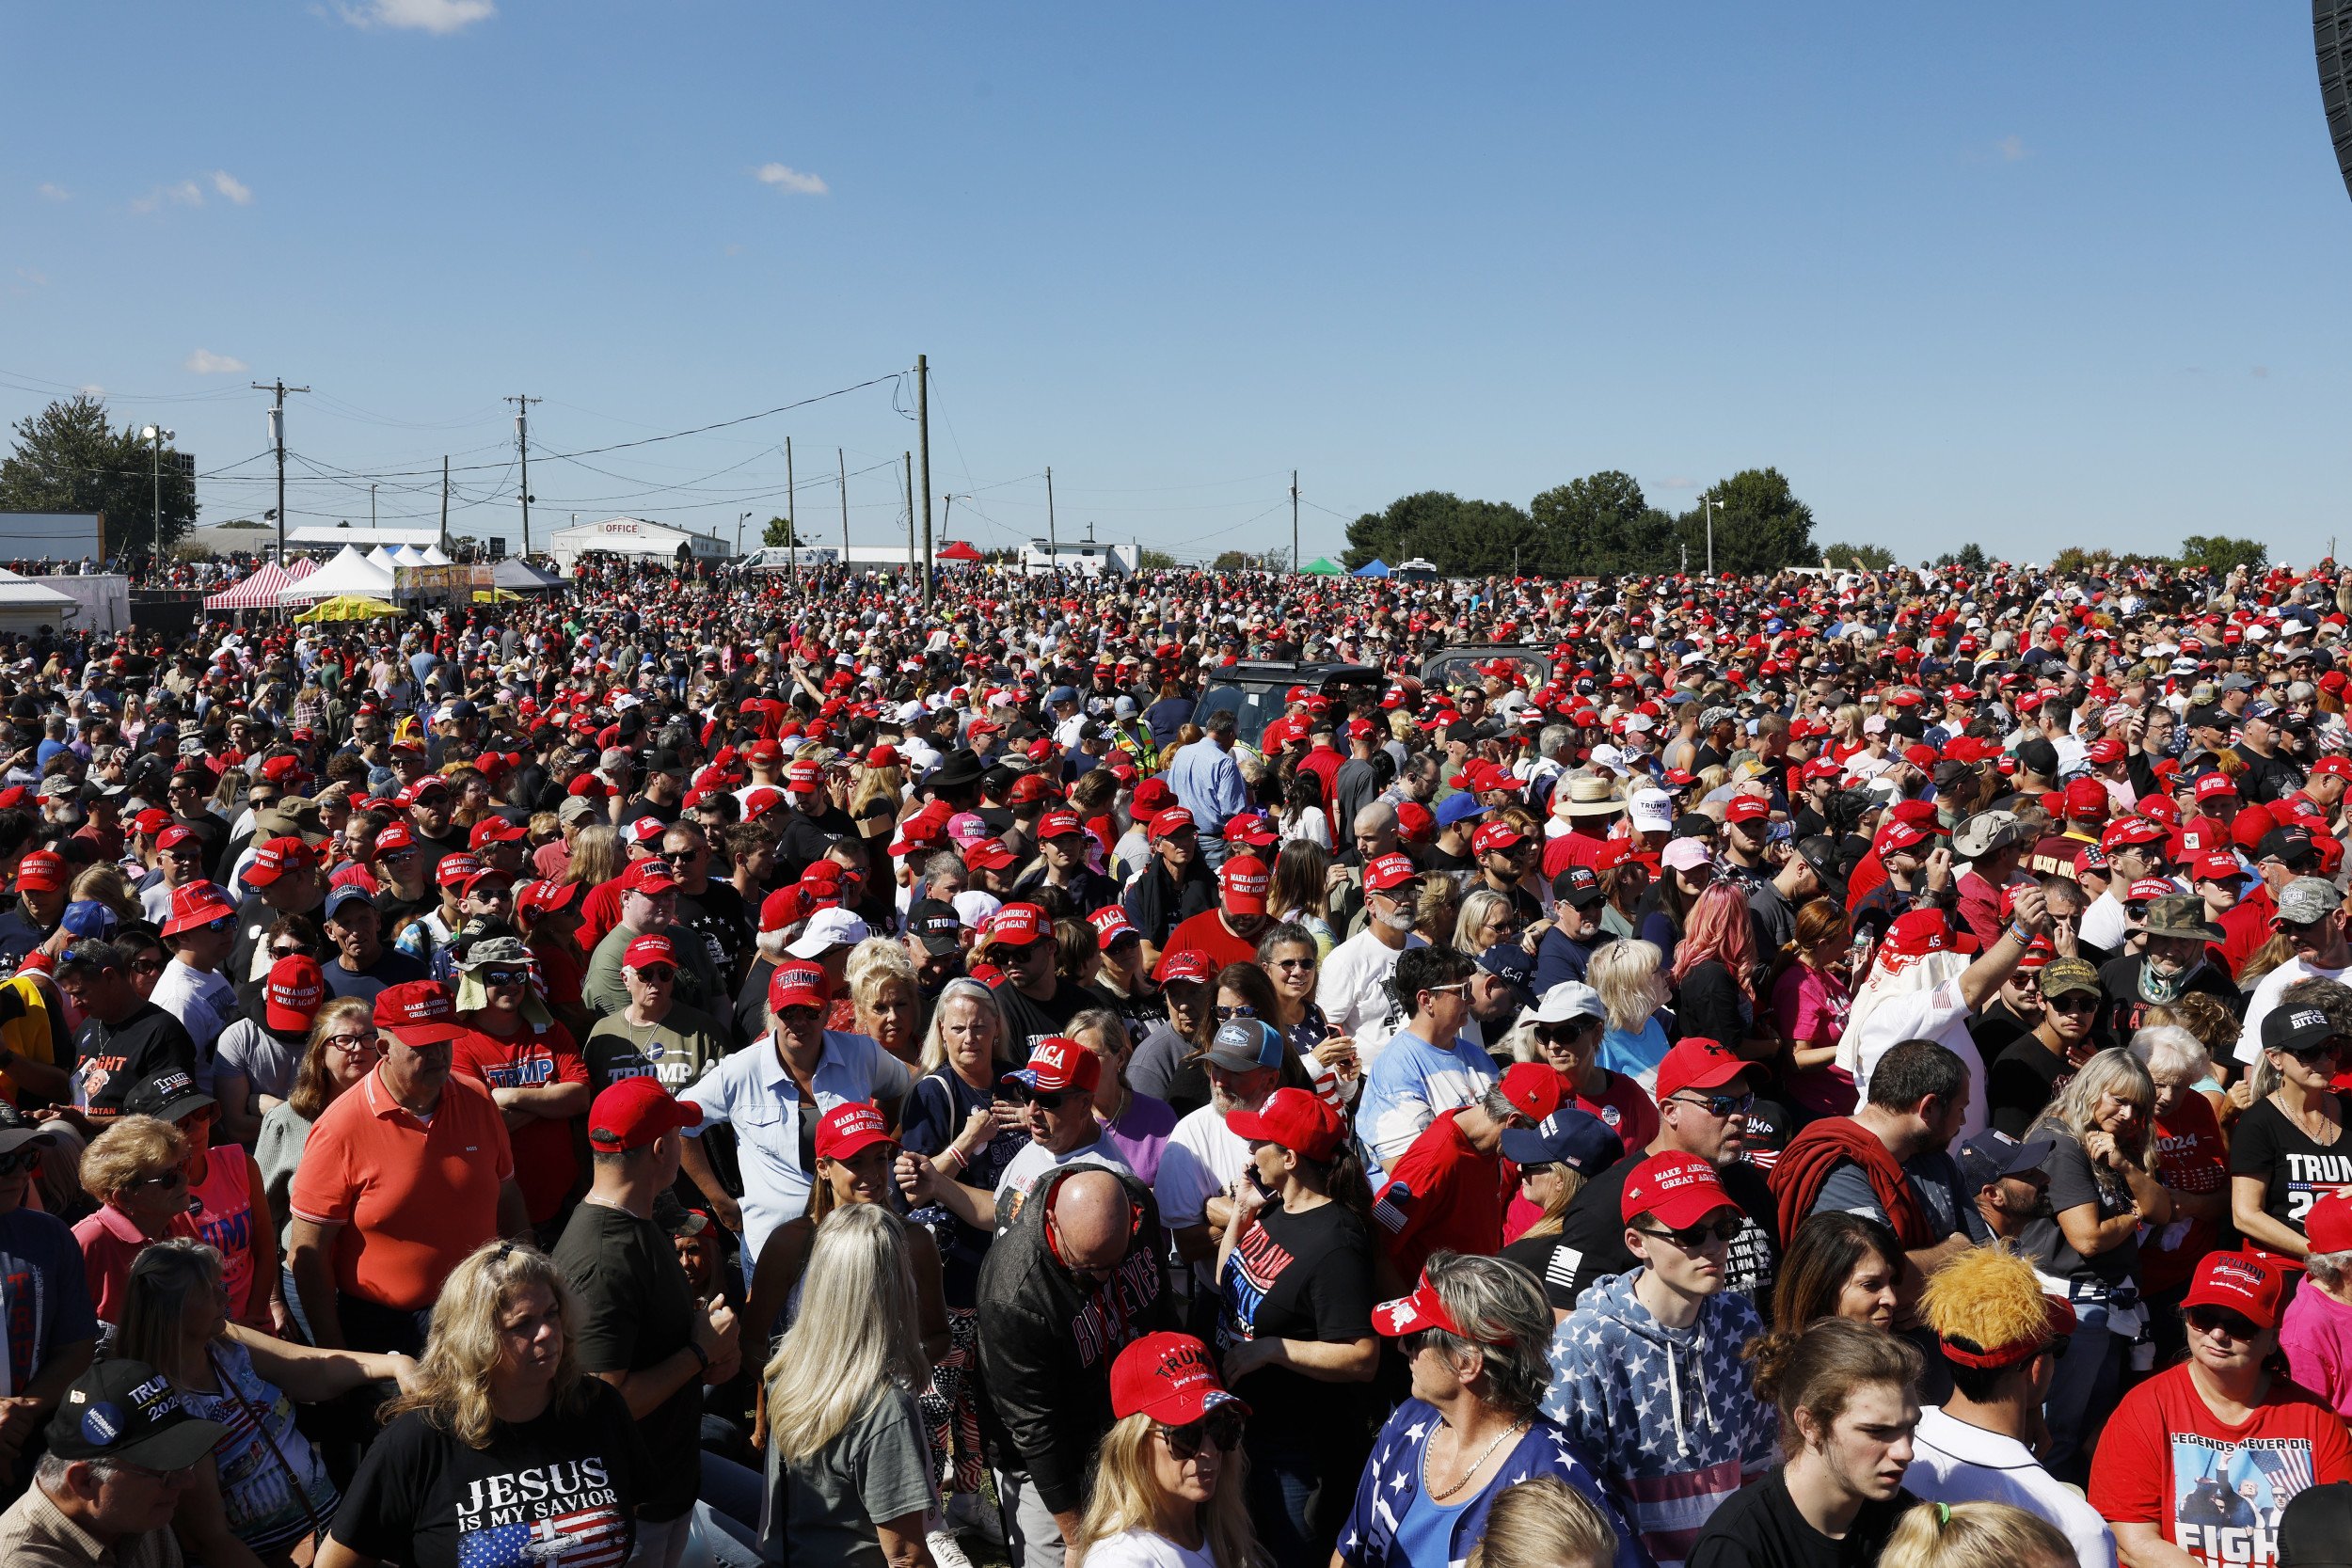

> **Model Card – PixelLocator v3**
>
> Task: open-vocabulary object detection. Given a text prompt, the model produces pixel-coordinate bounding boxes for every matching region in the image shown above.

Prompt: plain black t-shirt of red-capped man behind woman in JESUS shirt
[553,1204,704,1521]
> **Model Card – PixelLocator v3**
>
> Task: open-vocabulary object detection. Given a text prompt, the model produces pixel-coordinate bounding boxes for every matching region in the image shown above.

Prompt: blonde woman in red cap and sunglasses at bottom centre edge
[1071,1333,1273,1568]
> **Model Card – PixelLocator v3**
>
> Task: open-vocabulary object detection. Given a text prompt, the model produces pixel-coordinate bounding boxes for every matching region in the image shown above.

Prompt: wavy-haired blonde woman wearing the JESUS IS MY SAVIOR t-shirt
[315,1242,652,1568]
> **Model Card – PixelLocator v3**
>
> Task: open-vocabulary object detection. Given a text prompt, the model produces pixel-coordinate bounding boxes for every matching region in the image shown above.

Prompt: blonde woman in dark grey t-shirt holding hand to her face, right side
[2018,1049,2173,1486]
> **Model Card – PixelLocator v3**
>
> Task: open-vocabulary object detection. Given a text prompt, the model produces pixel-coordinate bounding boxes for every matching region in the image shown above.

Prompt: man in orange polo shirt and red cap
[287,980,530,1356]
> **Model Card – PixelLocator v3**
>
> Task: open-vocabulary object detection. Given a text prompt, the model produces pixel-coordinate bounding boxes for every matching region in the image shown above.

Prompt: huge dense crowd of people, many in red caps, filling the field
[0,549,2352,1568]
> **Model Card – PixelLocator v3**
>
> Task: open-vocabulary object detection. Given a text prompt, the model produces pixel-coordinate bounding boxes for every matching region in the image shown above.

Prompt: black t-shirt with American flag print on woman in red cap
[1216,1199,1374,1446]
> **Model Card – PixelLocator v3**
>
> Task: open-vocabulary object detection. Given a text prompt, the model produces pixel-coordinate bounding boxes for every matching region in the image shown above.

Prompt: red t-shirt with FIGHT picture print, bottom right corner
[2089,1364,2352,1568]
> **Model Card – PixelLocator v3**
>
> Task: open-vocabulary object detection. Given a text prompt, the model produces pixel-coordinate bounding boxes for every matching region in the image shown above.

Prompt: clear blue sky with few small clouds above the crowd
[0,0,2352,562]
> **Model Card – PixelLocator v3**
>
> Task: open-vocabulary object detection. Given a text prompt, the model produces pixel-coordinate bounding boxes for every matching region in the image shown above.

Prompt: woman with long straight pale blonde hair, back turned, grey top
[760,1204,939,1568]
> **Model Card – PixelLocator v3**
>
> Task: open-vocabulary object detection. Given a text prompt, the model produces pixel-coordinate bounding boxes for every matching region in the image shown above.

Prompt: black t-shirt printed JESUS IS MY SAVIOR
[329,1378,652,1568]
